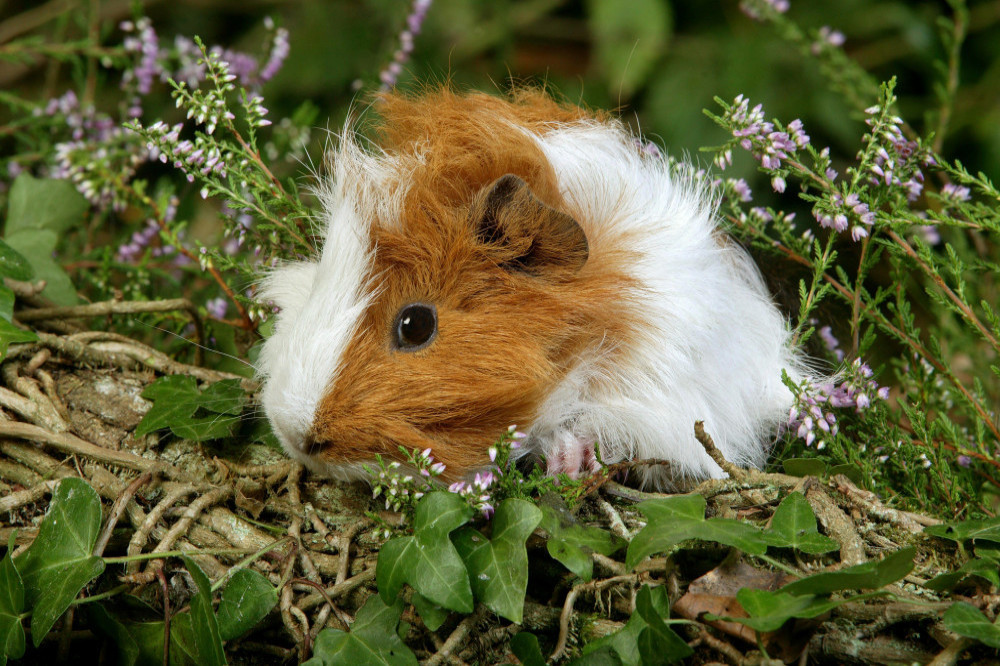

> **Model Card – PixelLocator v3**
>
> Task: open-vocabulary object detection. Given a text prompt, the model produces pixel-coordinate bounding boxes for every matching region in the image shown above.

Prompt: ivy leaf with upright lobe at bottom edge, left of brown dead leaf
[583,585,693,666]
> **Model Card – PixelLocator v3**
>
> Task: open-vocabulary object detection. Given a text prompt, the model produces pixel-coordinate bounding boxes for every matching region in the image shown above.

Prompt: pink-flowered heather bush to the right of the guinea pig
[709,2,1000,501]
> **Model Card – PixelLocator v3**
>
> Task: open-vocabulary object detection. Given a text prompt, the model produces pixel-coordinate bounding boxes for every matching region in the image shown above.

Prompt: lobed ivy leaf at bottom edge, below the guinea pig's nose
[303,594,417,666]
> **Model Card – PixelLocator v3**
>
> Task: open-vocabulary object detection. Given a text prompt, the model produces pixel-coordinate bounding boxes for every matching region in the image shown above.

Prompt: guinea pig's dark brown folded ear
[473,174,589,275]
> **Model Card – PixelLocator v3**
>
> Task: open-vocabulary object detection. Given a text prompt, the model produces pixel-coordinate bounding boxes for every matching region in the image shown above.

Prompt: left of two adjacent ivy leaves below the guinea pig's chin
[375,492,472,613]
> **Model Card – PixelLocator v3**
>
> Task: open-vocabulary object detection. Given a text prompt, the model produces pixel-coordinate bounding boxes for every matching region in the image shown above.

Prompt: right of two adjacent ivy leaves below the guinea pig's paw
[452,499,542,624]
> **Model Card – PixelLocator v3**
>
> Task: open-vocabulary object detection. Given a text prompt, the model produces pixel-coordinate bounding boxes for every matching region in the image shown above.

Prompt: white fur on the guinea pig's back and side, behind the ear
[528,116,803,477]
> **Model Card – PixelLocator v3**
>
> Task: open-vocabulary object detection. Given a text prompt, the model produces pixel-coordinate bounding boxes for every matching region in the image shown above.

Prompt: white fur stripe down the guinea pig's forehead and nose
[257,133,406,477]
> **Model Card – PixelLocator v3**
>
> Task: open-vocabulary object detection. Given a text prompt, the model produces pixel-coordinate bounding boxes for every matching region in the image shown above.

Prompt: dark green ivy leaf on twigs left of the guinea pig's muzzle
[135,375,246,442]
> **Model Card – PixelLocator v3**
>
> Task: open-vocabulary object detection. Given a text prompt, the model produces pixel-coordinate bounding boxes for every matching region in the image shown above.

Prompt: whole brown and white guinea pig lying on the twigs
[258,89,808,486]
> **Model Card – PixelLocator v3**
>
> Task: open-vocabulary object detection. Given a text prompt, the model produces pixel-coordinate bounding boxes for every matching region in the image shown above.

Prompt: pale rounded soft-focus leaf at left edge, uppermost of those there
[4,173,90,236]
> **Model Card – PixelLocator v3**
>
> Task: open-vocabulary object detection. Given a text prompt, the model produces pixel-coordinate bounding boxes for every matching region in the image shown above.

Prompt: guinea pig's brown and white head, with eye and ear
[259,114,592,480]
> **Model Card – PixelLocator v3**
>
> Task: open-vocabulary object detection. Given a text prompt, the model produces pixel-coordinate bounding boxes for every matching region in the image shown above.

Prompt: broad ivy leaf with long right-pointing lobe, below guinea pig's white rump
[625,495,767,569]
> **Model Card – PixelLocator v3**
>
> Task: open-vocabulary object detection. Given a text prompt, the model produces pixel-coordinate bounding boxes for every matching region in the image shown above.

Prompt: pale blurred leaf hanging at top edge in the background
[587,0,672,95]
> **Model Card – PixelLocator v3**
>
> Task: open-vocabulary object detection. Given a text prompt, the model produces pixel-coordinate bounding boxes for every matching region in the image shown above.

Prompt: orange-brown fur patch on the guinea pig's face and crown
[312,90,635,480]
